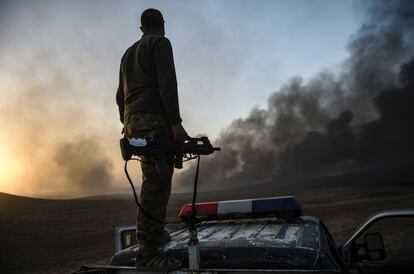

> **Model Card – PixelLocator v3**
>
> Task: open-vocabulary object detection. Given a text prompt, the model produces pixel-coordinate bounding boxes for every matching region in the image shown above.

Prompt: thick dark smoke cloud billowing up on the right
[179,0,414,187]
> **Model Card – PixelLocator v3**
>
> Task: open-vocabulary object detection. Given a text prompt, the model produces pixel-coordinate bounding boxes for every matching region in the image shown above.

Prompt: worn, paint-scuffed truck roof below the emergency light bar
[111,217,335,270]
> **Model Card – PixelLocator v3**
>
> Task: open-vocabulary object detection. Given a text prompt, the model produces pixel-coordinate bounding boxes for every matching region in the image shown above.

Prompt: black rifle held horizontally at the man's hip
[120,136,221,168]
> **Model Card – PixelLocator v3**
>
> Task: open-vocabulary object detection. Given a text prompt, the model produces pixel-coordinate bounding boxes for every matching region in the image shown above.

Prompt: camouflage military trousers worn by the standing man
[124,114,174,256]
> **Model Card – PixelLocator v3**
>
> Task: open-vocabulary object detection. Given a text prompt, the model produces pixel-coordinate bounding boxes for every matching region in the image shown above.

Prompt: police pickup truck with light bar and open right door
[74,196,414,274]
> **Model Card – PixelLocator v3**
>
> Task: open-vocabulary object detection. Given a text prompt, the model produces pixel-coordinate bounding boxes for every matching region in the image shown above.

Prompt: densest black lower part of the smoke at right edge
[280,58,414,172]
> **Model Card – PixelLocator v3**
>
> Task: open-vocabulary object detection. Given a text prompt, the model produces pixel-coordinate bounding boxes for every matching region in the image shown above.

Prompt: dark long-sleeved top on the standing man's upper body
[117,34,181,125]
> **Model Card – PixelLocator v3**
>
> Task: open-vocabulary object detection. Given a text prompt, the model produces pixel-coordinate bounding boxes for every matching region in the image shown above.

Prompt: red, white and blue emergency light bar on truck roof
[179,196,302,220]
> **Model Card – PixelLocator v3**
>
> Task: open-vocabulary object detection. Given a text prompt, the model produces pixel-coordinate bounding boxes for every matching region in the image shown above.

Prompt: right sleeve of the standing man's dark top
[154,38,182,126]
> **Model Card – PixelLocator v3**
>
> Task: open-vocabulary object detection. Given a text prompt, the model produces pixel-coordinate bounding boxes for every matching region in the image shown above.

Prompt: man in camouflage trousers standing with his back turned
[116,9,188,271]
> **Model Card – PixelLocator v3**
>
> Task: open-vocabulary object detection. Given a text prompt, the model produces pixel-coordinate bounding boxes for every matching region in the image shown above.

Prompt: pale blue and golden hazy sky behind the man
[0,0,360,196]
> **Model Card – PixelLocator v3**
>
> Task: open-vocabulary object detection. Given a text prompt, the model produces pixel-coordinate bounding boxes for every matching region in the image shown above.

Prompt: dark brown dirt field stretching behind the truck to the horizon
[0,182,414,273]
